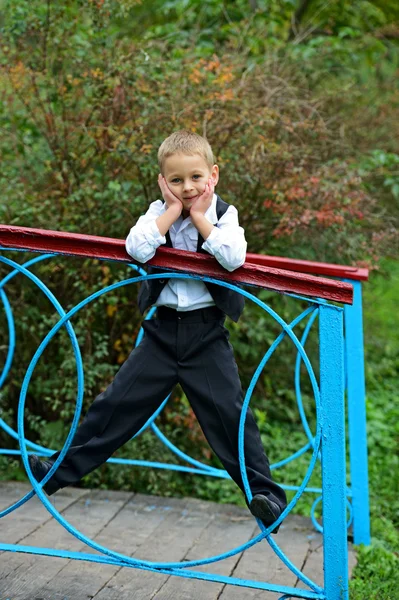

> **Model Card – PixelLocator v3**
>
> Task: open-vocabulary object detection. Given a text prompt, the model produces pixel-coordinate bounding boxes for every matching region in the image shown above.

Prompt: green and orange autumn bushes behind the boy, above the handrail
[0,0,396,261]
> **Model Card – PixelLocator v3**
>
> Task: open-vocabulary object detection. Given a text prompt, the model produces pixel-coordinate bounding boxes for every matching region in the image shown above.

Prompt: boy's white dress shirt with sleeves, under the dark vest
[125,194,247,311]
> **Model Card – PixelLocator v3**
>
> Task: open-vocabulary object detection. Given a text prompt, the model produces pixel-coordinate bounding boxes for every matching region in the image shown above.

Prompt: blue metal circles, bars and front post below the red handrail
[0,246,368,600]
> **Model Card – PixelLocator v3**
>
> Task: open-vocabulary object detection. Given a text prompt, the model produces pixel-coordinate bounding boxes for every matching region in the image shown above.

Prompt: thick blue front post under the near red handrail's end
[319,305,349,600]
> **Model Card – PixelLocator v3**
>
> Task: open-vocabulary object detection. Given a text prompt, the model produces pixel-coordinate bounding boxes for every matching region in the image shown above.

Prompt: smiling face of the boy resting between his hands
[163,154,219,211]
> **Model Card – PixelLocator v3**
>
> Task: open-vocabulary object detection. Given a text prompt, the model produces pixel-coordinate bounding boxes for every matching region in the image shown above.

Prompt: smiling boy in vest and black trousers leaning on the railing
[29,130,286,533]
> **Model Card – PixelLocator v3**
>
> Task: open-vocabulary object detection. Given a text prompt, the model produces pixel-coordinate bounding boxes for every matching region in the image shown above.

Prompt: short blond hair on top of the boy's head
[158,129,215,174]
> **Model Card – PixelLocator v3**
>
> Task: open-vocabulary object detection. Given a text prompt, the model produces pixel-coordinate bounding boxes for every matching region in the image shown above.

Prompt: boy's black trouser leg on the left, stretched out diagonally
[45,320,177,493]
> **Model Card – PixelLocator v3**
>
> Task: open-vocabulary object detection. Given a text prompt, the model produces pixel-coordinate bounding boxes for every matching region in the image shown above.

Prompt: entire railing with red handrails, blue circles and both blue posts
[0,226,369,600]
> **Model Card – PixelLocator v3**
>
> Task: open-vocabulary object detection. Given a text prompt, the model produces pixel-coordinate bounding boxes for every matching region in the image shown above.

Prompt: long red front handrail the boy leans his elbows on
[0,225,353,304]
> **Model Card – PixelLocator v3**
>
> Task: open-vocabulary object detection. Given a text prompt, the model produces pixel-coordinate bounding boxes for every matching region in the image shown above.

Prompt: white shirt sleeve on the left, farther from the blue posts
[125,200,166,263]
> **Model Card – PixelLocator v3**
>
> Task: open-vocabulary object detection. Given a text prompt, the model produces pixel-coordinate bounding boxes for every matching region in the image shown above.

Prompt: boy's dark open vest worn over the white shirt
[138,196,244,321]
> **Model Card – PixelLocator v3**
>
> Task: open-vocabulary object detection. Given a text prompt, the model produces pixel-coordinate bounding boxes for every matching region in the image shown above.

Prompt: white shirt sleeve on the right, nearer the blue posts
[202,205,247,271]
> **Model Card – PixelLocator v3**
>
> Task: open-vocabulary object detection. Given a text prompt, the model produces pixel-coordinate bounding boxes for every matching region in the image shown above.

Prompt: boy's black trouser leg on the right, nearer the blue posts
[178,322,287,509]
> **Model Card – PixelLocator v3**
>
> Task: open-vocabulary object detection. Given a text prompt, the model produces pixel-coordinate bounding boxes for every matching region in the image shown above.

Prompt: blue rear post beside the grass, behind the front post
[345,280,370,545]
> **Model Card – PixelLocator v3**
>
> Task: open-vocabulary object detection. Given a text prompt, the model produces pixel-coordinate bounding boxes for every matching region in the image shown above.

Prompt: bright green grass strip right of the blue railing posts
[350,260,399,600]
